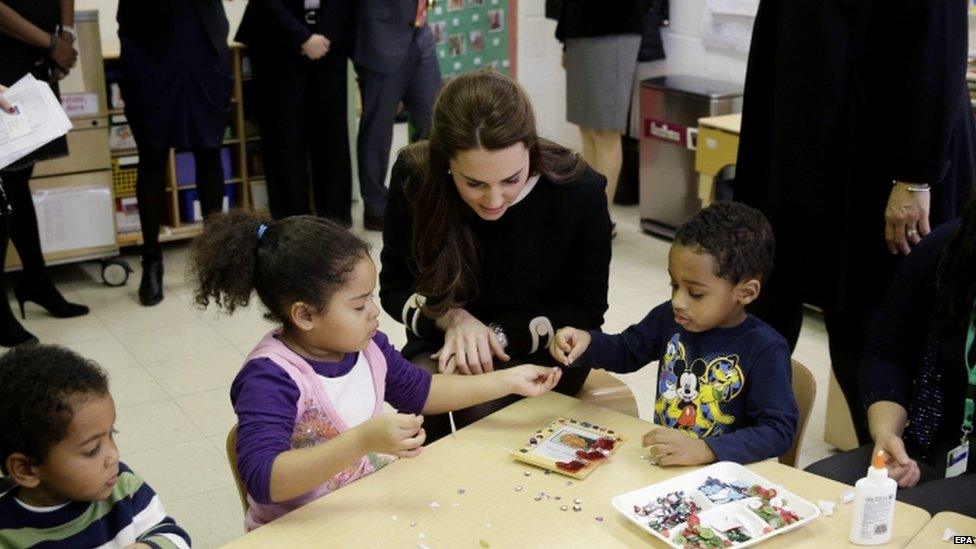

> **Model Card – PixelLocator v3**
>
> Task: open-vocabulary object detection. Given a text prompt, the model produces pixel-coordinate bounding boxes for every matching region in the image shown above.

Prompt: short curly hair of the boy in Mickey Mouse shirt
[674,202,776,284]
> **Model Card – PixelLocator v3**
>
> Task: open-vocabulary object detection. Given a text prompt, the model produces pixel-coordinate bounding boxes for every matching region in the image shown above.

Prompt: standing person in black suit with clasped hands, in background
[236,0,352,227]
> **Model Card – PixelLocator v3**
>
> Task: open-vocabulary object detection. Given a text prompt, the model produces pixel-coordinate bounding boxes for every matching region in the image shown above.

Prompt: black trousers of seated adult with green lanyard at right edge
[806,444,976,516]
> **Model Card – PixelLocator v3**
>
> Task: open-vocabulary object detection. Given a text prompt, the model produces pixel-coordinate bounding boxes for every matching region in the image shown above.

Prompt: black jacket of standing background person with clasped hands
[234,0,352,55]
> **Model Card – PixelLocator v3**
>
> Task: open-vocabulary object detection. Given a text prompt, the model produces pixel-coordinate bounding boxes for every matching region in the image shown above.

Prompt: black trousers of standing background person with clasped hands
[251,51,352,226]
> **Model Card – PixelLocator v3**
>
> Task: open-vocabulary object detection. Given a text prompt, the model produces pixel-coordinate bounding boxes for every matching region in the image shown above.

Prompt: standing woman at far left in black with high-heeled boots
[0,0,88,347]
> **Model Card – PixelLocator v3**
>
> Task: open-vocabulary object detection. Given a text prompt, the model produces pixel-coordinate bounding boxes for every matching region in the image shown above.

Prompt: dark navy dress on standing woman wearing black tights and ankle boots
[119,2,232,150]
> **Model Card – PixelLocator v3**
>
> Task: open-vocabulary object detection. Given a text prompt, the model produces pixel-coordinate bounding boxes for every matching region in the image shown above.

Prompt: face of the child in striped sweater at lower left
[23,394,119,505]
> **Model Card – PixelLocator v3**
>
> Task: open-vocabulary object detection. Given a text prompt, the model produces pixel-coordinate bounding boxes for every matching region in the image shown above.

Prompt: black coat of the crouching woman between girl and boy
[380,150,610,363]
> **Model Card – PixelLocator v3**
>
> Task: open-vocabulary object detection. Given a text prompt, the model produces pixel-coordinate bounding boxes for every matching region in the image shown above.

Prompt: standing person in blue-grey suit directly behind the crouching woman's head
[352,0,441,231]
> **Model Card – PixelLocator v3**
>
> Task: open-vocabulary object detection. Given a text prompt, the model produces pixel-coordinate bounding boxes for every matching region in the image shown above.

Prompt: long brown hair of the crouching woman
[404,70,586,317]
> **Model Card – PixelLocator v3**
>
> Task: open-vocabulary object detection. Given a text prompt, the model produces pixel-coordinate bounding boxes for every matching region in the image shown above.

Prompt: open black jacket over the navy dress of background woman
[116,0,230,56]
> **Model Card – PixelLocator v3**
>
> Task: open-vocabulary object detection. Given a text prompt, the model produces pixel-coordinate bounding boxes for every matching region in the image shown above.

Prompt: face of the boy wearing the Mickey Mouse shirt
[668,244,759,332]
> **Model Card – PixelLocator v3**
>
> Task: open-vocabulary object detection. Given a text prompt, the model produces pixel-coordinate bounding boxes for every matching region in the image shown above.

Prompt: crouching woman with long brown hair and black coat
[380,71,610,440]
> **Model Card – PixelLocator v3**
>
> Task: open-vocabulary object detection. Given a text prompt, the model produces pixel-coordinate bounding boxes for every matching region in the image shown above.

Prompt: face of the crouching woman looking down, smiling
[450,142,529,221]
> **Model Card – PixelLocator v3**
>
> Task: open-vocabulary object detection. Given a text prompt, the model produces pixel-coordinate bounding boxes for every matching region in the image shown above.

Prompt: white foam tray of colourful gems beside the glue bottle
[612,461,820,549]
